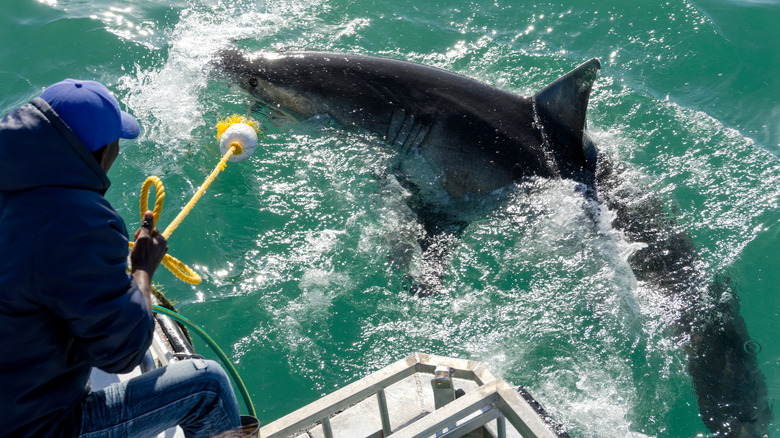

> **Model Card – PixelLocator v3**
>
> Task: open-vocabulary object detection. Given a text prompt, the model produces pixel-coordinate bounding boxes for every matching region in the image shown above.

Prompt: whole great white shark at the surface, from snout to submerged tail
[216,50,772,437]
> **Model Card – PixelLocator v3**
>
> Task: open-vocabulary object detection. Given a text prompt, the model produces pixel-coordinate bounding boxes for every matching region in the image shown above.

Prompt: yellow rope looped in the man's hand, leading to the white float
[130,142,242,284]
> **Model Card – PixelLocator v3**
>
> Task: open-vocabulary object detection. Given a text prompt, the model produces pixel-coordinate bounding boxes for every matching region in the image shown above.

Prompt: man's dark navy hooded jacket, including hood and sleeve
[0,98,154,437]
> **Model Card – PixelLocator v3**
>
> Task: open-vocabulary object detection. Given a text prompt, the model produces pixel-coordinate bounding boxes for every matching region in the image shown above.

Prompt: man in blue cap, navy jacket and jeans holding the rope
[0,79,240,437]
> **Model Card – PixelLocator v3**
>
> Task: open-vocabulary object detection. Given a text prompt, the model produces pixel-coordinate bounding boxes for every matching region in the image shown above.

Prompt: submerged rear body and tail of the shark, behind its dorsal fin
[597,156,772,438]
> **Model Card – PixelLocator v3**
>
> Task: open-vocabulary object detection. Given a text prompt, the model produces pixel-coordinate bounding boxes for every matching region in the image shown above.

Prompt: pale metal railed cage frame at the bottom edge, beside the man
[260,353,566,438]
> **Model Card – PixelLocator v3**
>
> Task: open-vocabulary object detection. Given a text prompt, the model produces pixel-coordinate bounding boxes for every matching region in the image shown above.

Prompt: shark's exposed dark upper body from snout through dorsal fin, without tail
[221,51,599,196]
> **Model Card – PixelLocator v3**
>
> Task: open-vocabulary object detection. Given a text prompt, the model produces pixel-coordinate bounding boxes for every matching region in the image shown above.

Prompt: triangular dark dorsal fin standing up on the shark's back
[534,58,601,138]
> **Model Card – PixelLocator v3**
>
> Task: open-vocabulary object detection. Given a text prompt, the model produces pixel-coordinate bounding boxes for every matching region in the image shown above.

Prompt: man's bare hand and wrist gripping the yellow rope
[130,211,168,310]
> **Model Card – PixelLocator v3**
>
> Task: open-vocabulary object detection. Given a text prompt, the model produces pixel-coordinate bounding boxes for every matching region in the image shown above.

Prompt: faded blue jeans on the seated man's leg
[79,359,240,438]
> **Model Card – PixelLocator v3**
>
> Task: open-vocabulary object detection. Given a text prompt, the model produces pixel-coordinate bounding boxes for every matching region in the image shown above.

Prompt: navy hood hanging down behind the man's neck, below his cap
[0,97,111,193]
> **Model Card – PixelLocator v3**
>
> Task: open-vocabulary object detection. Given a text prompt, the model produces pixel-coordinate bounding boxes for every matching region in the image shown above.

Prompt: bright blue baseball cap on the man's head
[41,79,141,152]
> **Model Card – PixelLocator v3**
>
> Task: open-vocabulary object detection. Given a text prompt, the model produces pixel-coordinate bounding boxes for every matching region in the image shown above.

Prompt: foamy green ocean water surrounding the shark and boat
[0,0,780,437]
